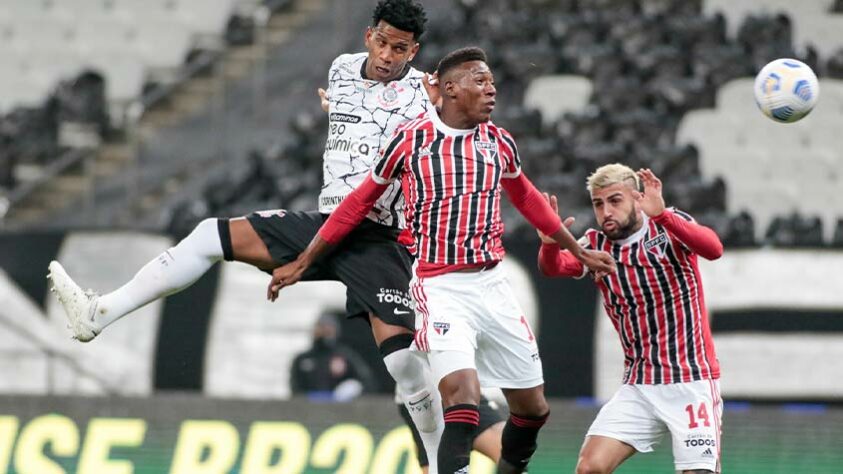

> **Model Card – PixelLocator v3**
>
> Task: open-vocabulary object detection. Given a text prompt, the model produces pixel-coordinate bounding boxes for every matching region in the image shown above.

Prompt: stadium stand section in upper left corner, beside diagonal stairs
[0,0,292,226]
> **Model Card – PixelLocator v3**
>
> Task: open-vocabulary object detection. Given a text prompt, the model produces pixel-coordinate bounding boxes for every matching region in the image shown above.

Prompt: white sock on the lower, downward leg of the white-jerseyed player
[383,349,445,474]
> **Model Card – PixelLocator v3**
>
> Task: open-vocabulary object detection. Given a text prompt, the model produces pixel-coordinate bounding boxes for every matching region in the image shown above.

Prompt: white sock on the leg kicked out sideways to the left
[94,219,223,328]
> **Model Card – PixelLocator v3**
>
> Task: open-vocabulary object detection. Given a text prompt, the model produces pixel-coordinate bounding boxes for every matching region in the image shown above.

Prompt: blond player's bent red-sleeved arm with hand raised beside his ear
[638,169,723,260]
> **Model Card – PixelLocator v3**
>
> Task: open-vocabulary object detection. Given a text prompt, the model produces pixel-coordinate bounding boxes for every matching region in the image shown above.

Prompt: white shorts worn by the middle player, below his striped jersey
[410,265,544,388]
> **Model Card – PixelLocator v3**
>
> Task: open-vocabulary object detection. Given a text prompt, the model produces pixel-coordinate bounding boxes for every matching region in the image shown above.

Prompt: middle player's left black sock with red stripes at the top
[437,403,480,474]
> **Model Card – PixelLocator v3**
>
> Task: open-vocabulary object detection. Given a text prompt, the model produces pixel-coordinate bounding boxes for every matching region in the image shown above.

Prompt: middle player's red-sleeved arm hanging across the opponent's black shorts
[266,175,389,301]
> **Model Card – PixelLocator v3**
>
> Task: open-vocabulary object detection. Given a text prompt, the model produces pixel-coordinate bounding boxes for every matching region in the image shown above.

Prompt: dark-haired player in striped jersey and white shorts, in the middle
[267,48,615,474]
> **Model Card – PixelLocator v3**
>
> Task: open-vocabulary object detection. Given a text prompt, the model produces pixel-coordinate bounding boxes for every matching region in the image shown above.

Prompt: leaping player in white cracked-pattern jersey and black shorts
[49,0,443,466]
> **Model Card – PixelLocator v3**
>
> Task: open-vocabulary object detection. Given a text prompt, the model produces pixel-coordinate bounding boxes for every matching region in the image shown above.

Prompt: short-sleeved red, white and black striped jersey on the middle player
[372,111,521,276]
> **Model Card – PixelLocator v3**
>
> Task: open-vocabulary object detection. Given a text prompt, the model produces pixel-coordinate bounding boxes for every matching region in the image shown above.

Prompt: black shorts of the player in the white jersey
[247,210,415,331]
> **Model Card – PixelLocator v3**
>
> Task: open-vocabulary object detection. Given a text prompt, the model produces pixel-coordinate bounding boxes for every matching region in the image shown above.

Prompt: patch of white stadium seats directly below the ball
[677,79,843,241]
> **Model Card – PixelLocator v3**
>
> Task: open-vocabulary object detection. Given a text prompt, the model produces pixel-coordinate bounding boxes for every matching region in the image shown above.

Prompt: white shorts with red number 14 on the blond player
[586,380,723,472]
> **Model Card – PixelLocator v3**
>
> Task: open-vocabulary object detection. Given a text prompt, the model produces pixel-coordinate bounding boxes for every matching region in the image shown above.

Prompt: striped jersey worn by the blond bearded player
[581,210,720,384]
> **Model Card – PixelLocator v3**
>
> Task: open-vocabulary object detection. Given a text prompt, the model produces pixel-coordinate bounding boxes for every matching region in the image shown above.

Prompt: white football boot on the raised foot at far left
[47,260,102,342]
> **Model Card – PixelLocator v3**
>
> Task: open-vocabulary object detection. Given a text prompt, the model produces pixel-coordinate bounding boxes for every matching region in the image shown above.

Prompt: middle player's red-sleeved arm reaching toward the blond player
[501,173,616,278]
